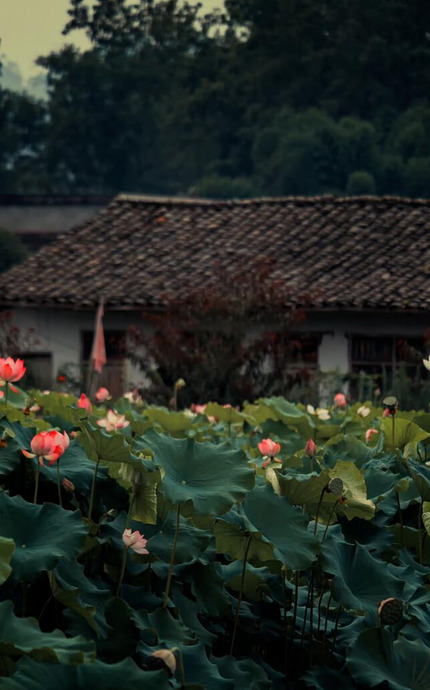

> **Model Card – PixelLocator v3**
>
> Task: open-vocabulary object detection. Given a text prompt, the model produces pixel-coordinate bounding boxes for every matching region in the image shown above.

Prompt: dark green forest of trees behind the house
[0,0,430,198]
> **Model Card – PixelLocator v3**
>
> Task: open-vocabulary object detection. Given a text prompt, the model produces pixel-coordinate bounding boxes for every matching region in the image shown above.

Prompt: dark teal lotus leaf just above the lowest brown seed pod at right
[320,536,404,612]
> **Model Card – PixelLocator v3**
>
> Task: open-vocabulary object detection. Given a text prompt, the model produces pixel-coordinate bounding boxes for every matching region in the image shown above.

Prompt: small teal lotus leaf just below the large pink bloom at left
[40,441,107,496]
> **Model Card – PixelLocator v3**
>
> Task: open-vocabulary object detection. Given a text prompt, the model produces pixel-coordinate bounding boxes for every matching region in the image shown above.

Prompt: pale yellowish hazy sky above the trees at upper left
[0,0,221,80]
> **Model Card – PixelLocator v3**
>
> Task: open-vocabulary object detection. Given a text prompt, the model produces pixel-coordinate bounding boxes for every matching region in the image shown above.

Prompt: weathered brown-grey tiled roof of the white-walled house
[0,195,430,311]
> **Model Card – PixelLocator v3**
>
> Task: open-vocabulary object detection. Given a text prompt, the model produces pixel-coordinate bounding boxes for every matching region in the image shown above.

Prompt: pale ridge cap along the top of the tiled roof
[113,192,430,206]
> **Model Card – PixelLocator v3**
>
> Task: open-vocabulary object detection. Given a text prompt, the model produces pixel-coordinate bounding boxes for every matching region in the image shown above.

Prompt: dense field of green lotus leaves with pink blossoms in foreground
[0,378,430,690]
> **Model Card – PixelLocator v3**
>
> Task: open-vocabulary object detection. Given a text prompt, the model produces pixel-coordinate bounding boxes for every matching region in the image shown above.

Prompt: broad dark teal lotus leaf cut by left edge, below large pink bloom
[0,492,87,582]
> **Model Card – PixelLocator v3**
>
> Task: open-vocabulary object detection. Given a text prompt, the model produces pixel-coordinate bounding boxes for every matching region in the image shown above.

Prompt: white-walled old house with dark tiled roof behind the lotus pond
[0,194,430,398]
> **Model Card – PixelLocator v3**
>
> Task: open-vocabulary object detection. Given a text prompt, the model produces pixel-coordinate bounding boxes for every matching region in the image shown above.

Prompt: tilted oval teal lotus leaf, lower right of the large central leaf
[242,485,318,570]
